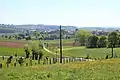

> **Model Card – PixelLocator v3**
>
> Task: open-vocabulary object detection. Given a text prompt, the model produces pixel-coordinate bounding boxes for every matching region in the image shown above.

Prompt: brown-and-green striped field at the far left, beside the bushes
[0,40,25,56]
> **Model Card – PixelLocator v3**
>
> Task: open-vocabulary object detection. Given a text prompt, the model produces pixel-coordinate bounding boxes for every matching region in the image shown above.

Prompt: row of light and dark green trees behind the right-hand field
[75,30,120,48]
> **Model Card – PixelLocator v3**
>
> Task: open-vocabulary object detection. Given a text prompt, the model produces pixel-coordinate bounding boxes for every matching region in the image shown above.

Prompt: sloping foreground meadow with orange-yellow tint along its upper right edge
[0,59,120,80]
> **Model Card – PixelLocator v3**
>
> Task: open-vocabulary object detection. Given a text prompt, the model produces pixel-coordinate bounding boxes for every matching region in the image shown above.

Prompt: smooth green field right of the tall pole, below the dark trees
[63,47,120,58]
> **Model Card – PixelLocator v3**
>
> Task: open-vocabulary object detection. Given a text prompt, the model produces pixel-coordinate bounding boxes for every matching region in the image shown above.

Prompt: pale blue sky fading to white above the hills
[0,0,120,27]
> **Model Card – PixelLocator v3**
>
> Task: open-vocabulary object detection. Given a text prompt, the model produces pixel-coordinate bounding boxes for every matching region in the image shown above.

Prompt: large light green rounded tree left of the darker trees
[75,30,92,46]
